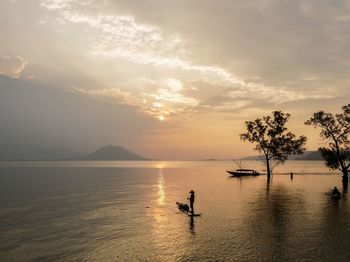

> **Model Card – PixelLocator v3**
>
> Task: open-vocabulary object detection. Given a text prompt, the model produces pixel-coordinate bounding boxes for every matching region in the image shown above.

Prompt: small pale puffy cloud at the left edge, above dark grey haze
[0,56,28,78]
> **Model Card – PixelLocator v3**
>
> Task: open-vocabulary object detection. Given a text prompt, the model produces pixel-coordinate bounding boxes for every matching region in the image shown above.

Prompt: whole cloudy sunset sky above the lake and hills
[0,0,350,159]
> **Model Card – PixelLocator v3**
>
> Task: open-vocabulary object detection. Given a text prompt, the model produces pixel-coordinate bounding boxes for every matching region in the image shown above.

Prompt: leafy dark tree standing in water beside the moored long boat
[240,111,306,181]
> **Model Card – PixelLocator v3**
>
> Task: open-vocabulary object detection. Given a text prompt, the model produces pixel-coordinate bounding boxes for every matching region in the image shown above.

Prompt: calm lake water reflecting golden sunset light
[0,161,350,261]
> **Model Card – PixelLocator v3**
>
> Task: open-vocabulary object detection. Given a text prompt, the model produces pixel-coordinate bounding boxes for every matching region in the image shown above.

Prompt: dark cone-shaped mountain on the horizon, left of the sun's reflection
[80,145,146,160]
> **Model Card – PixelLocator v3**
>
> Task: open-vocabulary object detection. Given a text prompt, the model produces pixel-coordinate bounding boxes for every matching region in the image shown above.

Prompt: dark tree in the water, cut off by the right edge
[305,104,350,187]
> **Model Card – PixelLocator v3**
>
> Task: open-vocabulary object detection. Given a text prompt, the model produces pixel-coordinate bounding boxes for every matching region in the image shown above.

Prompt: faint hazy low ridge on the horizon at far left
[0,143,83,160]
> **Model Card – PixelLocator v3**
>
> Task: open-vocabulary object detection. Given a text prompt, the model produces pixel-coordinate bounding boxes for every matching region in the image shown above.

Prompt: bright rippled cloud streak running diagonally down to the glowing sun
[37,0,336,118]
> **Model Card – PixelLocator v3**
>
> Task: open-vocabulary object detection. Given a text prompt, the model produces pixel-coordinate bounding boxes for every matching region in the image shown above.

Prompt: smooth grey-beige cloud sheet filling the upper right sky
[104,0,350,89]
